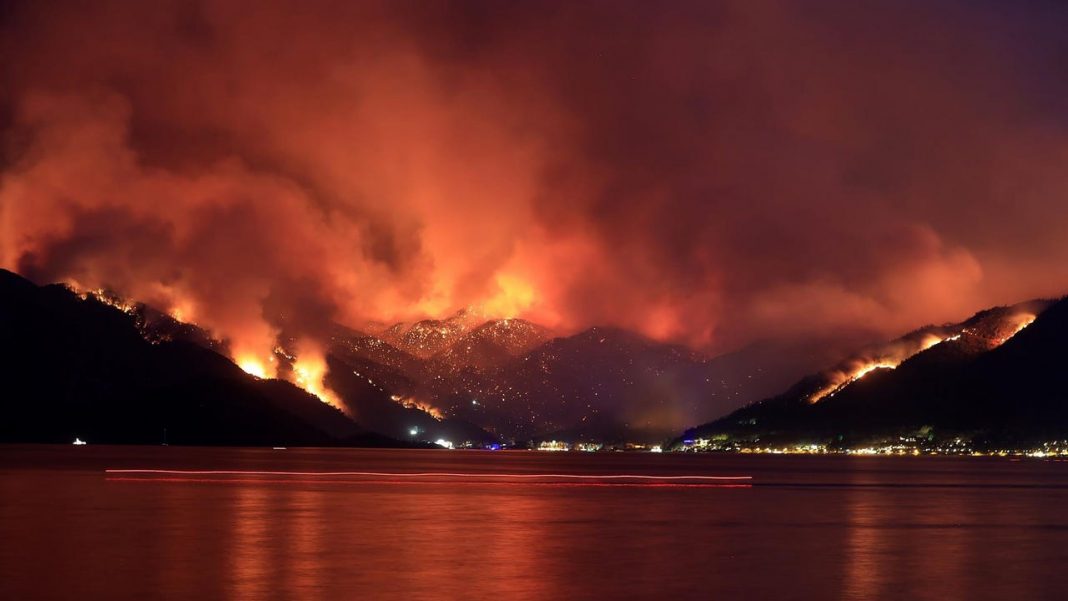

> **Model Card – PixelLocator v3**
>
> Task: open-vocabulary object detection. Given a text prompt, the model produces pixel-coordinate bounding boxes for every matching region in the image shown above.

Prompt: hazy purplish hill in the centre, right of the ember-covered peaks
[429,328,837,442]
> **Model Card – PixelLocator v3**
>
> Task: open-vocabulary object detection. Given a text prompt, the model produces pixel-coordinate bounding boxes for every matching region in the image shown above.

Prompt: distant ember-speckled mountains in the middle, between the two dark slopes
[316,313,850,442]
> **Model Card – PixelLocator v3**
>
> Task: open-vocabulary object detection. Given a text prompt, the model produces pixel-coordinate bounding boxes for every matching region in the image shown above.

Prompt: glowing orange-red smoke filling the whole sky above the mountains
[0,0,1068,360]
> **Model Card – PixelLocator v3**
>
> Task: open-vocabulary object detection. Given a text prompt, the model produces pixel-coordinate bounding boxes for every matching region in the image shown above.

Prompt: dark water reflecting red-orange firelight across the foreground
[0,446,1068,600]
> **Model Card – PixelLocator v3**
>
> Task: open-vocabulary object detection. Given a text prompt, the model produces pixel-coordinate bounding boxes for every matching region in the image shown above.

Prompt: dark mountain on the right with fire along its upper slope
[685,299,1068,446]
